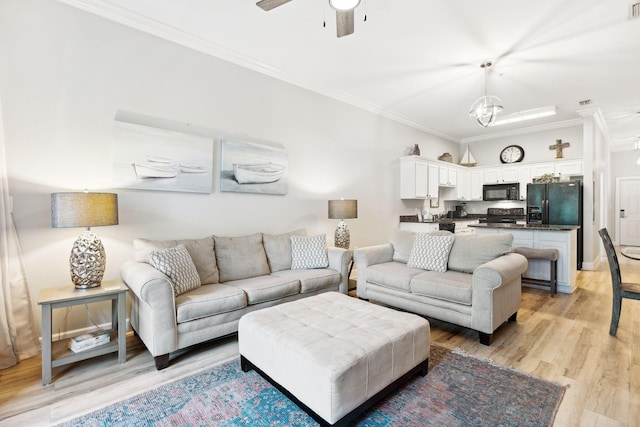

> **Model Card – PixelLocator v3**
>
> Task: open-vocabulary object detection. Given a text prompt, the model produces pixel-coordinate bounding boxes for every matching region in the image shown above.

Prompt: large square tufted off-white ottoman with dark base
[238,292,430,425]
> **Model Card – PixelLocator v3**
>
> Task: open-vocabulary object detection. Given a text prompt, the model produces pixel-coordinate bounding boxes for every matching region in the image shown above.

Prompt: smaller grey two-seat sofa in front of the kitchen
[354,230,527,345]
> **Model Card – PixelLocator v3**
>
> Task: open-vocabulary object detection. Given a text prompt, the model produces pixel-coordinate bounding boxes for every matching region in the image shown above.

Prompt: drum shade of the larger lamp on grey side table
[51,192,118,228]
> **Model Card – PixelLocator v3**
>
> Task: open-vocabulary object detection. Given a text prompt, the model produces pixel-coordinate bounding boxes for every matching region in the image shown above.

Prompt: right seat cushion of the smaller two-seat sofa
[411,271,473,306]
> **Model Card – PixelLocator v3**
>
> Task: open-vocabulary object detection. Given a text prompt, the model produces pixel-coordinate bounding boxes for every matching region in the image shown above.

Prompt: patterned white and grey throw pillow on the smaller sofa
[407,233,456,272]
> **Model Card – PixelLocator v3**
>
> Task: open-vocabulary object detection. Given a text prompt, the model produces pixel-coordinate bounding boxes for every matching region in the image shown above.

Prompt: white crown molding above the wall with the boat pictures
[53,0,460,143]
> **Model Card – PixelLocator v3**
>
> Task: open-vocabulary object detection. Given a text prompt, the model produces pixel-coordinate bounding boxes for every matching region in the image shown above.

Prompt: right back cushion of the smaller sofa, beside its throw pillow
[449,233,513,273]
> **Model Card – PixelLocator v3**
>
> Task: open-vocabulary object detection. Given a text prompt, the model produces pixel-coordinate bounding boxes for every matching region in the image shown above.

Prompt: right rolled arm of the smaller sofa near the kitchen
[471,253,528,334]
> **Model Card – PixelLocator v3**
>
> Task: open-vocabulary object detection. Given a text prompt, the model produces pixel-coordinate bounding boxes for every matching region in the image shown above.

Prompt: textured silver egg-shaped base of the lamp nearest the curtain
[69,230,107,289]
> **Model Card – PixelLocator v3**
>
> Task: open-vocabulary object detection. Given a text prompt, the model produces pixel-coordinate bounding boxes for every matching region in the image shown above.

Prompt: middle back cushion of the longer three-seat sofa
[213,233,270,283]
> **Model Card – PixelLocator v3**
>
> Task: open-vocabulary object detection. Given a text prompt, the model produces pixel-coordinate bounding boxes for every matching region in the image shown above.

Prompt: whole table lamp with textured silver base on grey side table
[51,192,118,289]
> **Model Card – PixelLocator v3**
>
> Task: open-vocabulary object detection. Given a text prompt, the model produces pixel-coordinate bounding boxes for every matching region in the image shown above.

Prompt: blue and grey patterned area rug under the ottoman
[60,346,564,427]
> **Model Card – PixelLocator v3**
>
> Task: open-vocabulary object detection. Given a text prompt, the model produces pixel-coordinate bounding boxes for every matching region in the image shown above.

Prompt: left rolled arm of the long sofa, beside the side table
[120,261,178,357]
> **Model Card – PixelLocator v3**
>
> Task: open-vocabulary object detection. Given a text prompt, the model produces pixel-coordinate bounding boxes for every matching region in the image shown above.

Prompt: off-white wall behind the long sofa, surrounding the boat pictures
[0,0,458,332]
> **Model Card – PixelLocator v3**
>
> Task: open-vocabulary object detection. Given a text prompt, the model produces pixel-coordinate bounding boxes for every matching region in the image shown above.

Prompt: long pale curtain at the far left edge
[0,95,40,369]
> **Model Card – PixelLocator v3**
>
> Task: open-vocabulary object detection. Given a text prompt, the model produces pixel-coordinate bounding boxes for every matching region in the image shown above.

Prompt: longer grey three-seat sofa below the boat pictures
[121,230,351,369]
